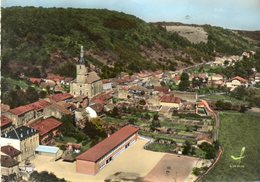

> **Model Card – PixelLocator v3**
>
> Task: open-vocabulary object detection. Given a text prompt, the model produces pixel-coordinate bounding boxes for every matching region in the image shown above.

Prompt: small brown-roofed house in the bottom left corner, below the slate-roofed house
[1,155,19,176]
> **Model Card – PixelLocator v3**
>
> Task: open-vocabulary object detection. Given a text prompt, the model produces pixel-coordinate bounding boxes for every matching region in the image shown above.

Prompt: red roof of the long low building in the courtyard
[76,125,138,162]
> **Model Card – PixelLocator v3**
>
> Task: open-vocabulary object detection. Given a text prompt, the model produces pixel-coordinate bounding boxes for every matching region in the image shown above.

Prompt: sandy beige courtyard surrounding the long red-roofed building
[31,139,198,182]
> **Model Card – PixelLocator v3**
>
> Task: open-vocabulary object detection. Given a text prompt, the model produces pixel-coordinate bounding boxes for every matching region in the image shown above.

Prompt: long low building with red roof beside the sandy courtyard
[76,125,138,175]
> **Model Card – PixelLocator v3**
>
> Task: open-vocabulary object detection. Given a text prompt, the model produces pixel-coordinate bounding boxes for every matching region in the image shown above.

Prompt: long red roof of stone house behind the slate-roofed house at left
[9,100,51,116]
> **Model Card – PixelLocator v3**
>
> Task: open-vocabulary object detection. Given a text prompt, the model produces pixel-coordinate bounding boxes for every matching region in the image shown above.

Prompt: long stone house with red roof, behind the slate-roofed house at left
[4,100,51,126]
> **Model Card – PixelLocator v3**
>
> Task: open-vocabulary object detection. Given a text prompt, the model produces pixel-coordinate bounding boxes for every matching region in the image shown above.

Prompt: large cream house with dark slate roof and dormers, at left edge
[1,126,39,161]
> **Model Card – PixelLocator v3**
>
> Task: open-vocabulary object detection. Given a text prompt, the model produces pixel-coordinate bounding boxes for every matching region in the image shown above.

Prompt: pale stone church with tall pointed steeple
[70,46,103,99]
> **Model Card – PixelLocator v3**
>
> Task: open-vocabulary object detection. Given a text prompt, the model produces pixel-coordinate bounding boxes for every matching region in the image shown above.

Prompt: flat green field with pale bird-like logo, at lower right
[202,112,260,182]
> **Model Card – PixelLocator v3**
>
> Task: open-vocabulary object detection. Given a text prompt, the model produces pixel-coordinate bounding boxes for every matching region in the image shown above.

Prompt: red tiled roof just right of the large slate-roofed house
[30,118,62,136]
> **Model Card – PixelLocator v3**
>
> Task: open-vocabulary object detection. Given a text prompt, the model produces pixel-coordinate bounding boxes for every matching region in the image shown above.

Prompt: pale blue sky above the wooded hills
[1,0,260,30]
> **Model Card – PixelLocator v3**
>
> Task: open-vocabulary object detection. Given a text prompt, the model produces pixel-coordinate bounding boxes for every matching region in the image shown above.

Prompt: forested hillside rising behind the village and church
[2,7,252,78]
